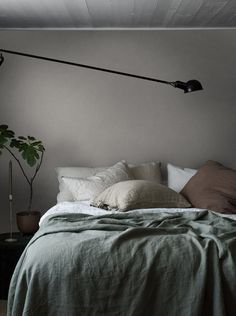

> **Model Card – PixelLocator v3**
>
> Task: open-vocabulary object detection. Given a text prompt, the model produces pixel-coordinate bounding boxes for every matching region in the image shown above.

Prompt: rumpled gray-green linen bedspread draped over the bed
[8,211,236,316]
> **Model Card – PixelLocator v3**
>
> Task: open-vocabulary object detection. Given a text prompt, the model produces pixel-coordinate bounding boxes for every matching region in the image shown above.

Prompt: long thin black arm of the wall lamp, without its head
[0,49,172,85]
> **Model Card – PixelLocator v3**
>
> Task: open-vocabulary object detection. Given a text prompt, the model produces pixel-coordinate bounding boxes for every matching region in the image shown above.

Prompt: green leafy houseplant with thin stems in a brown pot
[0,125,45,234]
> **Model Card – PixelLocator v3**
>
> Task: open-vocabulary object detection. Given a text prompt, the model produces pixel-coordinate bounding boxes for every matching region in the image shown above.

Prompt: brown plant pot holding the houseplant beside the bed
[16,211,41,235]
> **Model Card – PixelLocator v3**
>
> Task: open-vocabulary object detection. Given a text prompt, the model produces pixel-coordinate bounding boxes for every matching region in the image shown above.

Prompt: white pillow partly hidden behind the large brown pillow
[167,163,197,192]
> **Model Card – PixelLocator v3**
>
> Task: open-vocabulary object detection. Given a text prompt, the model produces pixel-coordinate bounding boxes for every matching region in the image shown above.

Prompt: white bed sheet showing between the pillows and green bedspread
[39,201,236,226]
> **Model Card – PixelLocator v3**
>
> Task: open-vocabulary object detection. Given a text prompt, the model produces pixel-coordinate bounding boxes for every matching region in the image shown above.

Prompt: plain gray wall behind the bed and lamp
[0,30,236,232]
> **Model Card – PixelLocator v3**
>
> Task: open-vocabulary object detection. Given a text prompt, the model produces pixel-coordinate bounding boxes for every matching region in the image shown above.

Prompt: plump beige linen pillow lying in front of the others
[91,180,191,211]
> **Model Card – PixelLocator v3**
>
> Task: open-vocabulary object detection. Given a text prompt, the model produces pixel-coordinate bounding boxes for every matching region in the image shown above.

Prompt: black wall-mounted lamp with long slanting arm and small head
[0,49,203,93]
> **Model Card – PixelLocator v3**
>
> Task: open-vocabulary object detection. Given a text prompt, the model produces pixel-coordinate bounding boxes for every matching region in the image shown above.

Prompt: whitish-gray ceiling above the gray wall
[0,0,236,29]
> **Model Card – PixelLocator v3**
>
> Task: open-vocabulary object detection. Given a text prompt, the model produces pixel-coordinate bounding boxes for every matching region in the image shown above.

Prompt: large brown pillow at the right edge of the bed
[180,160,236,213]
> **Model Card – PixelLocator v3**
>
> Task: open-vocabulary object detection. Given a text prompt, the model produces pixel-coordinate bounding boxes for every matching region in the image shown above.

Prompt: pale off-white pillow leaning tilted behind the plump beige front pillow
[62,161,133,201]
